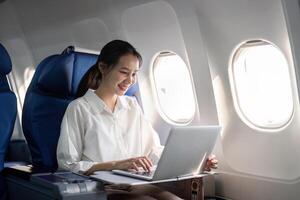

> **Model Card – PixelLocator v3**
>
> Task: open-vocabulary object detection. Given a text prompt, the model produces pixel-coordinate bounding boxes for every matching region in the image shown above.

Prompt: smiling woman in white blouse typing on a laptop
[57,40,216,199]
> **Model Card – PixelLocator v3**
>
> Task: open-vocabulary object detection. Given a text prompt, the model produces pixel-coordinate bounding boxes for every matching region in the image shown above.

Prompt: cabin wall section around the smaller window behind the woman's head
[1,0,218,143]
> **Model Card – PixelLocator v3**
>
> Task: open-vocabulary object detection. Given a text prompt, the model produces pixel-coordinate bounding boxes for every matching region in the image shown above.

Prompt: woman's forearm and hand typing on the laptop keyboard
[84,156,153,176]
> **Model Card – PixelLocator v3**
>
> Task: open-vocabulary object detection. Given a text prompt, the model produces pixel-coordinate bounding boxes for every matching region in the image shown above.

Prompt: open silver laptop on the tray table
[113,126,221,181]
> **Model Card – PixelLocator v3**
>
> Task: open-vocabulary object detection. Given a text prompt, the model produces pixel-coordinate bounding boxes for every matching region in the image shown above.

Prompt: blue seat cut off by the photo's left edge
[0,44,17,171]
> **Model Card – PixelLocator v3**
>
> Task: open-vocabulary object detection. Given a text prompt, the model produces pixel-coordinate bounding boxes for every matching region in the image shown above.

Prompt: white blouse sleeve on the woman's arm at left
[57,103,96,172]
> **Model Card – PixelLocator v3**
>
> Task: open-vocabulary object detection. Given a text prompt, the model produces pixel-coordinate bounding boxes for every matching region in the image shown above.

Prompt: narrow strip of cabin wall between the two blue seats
[0,1,34,139]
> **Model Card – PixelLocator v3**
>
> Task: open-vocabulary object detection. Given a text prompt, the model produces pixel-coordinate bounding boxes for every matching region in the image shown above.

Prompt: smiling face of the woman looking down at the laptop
[100,54,139,96]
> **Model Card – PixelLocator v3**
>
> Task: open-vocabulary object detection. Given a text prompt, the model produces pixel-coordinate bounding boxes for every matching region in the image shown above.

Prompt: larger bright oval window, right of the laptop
[229,40,293,129]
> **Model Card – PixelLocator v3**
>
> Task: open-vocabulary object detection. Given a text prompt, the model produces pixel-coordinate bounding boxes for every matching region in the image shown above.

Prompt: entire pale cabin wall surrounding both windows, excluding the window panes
[0,0,300,200]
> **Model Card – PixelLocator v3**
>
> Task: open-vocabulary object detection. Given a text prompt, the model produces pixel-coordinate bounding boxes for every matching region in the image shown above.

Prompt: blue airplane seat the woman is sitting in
[22,47,138,171]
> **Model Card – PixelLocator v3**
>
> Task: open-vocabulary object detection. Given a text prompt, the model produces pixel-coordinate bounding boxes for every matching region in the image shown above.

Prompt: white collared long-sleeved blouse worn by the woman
[57,90,163,172]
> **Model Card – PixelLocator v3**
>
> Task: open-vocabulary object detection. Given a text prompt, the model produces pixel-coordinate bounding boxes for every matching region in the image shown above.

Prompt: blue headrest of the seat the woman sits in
[37,47,98,97]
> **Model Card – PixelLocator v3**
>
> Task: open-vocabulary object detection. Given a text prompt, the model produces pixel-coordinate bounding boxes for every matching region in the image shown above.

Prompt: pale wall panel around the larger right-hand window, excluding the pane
[195,0,300,200]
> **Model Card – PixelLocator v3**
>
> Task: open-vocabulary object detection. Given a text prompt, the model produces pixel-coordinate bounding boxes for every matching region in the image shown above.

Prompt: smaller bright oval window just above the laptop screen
[153,52,196,123]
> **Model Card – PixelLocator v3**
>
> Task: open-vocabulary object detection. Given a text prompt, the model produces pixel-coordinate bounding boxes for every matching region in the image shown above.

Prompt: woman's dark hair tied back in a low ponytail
[76,40,142,97]
